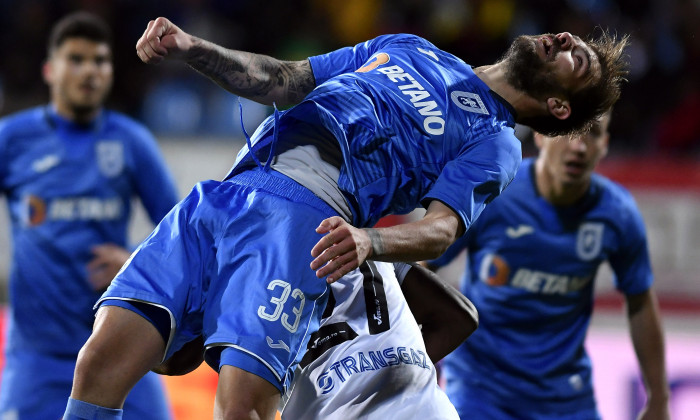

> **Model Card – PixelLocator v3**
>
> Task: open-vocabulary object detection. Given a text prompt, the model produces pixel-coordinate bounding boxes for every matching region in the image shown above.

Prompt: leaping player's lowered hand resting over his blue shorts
[311,216,372,284]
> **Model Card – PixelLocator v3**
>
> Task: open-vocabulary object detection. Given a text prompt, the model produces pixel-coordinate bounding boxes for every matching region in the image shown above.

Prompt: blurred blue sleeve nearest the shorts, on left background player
[128,127,178,224]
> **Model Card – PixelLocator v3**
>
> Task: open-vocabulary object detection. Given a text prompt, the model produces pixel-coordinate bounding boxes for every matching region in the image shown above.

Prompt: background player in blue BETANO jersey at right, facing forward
[432,114,669,420]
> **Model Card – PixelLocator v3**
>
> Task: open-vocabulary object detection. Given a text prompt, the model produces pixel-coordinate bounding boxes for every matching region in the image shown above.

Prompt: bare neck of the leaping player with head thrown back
[474,62,548,120]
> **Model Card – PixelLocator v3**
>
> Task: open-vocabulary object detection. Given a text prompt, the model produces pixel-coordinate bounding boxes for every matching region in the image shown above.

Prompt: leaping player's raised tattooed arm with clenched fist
[136,17,316,106]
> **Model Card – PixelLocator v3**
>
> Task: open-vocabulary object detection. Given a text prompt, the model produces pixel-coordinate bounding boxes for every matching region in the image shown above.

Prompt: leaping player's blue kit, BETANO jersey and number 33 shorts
[104,35,521,392]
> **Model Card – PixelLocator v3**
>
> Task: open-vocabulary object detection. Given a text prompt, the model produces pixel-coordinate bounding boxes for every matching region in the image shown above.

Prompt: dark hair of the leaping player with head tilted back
[522,30,629,137]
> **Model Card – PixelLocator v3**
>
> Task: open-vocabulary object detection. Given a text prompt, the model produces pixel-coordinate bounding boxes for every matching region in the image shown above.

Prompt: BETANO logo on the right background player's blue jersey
[479,254,593,295]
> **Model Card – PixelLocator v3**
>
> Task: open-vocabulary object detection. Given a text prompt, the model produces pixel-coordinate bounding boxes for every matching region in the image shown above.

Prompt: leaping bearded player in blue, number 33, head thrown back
[65,18,626,419]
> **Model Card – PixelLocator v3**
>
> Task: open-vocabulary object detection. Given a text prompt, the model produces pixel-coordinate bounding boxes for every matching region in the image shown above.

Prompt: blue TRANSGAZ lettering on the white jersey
[316,347,431,394]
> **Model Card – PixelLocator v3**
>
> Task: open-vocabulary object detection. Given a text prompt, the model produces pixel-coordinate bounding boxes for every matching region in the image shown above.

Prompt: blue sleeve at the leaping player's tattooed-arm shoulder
[309,34,420,85]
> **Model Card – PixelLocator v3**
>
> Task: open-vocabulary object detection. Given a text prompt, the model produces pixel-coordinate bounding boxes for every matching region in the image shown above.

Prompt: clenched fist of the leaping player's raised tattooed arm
[136,17,193,64]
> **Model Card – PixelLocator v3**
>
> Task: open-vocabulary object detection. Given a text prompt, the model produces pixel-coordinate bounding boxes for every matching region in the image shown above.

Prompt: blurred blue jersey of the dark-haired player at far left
[0,106,178,357]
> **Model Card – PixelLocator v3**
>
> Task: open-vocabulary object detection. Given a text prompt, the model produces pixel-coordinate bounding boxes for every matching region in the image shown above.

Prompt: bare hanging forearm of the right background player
[625,290,670,420]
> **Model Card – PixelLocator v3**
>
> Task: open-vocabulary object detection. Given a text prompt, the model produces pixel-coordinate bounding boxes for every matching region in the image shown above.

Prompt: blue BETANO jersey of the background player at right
[435,159,653,413]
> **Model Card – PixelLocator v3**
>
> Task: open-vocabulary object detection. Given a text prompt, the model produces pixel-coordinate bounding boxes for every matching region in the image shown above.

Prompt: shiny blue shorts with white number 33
[98,169,337,392]
